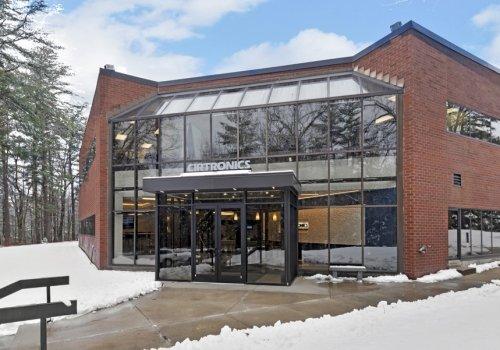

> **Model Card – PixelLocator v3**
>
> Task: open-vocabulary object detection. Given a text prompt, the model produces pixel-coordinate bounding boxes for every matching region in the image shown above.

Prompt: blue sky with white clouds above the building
[40,0,500,103]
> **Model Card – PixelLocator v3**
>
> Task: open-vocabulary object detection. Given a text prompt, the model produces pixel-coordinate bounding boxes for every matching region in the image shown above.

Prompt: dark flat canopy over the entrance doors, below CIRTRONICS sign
[143,170,300,192]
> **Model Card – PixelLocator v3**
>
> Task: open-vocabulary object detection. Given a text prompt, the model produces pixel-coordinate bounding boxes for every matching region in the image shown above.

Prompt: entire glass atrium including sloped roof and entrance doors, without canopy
[110,72,402,284]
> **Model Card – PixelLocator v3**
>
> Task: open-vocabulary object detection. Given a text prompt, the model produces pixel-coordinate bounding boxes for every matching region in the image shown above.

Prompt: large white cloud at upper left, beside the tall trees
[40,0,263,102]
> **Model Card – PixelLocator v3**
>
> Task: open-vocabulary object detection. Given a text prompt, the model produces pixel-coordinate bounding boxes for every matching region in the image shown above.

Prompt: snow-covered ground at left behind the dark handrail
[0,242,161,336]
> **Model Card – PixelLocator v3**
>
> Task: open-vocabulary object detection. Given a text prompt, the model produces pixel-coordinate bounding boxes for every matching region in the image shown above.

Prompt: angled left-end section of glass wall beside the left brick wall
[112,119,160,265]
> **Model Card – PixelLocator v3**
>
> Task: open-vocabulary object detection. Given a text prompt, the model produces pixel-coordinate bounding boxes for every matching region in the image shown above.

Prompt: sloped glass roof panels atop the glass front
[113,72,401,119]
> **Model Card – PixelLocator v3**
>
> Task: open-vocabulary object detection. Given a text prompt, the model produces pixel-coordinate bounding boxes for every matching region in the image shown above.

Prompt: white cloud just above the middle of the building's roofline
[216,29,366,73]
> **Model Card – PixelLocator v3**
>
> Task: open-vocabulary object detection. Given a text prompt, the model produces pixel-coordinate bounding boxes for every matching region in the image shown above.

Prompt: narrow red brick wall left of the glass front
[79,70,157,268]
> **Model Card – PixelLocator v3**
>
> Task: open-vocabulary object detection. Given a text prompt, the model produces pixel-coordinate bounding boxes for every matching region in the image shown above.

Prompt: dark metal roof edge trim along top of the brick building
[95,21,500,88]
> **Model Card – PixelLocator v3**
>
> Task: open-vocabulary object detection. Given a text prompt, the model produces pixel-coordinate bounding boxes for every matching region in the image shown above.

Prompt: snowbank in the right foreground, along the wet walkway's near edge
[158,280,500,350]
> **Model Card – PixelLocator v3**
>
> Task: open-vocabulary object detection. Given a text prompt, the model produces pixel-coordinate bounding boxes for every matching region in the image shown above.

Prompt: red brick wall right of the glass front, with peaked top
[357,32,500,277]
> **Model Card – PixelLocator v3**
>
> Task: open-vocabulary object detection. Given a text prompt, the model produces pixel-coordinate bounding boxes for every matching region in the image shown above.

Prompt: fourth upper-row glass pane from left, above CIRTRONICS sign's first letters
[186,114,210,160]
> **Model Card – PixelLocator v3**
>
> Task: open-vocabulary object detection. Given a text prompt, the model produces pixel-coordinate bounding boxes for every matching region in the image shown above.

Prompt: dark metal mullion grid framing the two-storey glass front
[109,91,404,272]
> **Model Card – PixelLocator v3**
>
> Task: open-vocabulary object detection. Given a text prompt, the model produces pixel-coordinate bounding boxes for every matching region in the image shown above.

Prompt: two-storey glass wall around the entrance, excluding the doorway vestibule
[112,74,398,272]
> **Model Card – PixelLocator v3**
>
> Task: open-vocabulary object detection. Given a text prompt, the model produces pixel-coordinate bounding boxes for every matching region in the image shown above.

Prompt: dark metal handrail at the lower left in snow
[0,276,77,350]
